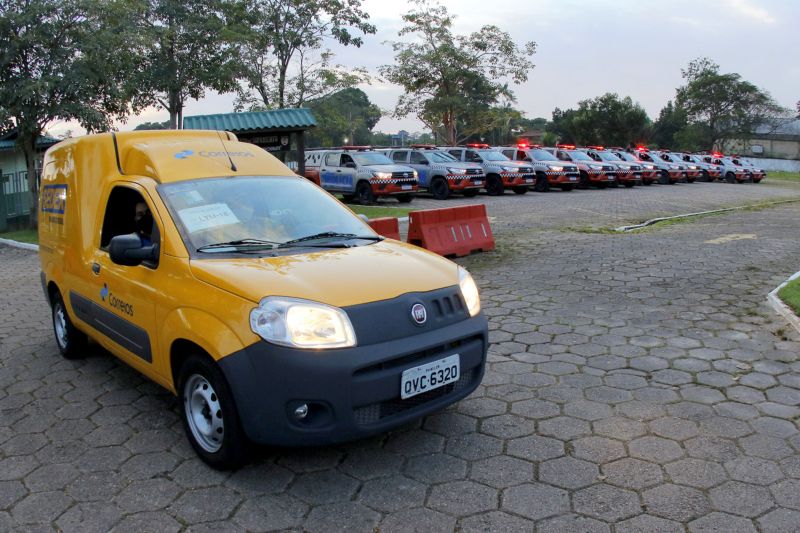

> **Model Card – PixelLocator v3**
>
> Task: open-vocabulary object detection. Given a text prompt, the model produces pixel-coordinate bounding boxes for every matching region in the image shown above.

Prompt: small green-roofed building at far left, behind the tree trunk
[0,130,60,231]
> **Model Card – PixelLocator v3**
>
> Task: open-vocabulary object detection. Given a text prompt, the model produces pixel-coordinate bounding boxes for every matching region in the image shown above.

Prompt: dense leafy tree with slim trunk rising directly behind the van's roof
[135,0,245,129]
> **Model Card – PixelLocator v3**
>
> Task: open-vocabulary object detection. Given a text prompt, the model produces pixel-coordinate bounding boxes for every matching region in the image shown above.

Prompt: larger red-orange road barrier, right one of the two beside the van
[408,204,494,257]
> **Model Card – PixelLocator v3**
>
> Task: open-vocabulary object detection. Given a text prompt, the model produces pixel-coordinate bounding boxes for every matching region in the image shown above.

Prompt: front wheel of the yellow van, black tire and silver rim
[178,354,250,470]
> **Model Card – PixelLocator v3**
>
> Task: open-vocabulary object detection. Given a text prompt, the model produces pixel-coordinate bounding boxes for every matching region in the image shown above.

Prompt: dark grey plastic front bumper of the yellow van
[219,313,488,446]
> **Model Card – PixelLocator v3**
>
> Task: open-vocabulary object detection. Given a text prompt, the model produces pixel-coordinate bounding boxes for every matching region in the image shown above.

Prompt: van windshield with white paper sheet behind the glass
[158,176,375,255]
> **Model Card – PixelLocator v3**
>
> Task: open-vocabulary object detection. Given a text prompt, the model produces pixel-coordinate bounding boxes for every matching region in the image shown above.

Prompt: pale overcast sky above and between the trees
[50,0,800,137]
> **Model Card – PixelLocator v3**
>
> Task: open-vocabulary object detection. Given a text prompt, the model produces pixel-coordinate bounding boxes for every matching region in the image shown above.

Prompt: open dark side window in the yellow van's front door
[100,185,160,264]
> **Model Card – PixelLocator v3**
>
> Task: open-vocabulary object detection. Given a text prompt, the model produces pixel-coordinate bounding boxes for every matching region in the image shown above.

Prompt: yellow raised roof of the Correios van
[48,130,294,183]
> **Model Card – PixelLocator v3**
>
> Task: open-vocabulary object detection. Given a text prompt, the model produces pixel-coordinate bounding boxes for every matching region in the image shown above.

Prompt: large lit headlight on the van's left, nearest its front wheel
[250,296,356,349]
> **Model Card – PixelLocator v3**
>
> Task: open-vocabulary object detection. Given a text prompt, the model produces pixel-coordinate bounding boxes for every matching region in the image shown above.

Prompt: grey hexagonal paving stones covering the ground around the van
[0,186,800,533]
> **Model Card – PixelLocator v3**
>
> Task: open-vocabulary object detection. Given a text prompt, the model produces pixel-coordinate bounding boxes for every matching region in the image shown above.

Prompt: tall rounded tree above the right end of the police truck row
[676,58,786,150]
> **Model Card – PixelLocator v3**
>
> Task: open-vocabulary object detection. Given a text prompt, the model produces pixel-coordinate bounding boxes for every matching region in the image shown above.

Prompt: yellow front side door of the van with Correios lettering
[83,183,160,371]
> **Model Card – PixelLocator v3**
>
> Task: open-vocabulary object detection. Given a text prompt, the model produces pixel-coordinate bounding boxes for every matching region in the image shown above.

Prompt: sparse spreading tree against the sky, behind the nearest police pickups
[381,0,536,144]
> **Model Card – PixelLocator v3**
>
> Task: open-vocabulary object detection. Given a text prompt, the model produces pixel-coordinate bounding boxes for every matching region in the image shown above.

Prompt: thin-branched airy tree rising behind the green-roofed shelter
[236,0,376,109]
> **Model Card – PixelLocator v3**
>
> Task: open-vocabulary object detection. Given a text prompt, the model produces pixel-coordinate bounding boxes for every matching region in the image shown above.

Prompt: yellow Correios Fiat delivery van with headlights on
[39,131,488,468]
